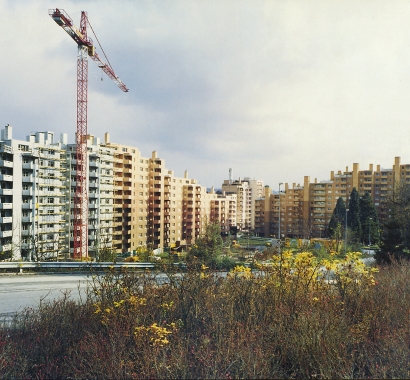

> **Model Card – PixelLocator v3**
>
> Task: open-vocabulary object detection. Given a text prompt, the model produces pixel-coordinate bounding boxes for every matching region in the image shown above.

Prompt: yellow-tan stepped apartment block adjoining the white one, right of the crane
[103,134,218,252]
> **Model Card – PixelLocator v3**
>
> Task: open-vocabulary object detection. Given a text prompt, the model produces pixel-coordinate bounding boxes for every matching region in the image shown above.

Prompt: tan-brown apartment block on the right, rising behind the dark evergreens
[254,157,410,238]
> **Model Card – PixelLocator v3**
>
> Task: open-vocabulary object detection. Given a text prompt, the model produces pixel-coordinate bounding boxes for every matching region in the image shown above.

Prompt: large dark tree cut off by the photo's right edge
[376,182,410,263]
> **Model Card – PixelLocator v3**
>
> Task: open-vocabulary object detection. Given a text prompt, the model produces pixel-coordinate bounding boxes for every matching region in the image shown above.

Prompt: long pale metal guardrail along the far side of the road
[0,261,155,273]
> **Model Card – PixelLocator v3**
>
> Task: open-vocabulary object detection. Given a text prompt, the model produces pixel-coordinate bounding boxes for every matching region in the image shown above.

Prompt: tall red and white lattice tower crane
[48,8,128,258]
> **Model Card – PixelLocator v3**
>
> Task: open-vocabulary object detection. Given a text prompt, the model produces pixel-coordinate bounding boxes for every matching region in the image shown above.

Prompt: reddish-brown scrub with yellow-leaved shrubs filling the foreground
[0,255,410,379]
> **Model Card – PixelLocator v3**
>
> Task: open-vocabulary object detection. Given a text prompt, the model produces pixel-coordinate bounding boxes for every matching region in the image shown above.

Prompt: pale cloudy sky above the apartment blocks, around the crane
[0,0,410,189]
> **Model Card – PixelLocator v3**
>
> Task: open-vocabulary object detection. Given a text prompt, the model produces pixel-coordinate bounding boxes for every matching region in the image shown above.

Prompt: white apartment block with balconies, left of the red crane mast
[0,125,68,259]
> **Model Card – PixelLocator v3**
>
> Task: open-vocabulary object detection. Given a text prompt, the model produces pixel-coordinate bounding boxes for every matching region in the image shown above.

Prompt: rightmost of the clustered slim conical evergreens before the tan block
[359,192,379,245]
